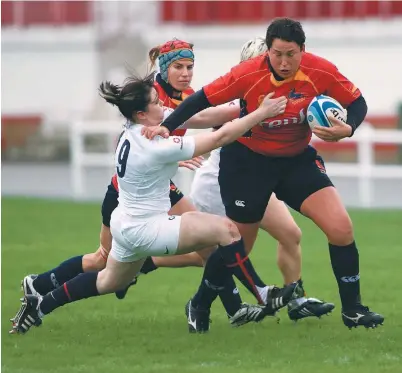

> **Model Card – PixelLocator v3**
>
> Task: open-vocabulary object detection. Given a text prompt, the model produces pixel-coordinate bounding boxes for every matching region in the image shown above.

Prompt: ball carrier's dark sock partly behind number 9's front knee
[191,250,229,309]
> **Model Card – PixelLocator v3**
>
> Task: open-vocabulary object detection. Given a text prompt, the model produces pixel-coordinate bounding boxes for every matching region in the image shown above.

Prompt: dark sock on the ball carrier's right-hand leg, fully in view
[328,241,360,309]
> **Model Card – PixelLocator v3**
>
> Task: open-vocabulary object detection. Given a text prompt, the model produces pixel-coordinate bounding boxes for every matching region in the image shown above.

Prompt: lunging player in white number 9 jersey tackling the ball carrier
[12,73,298,334]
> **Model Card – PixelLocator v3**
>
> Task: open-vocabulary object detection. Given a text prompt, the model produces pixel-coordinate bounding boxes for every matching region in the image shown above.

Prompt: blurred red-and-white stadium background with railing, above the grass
[1,1,402,208]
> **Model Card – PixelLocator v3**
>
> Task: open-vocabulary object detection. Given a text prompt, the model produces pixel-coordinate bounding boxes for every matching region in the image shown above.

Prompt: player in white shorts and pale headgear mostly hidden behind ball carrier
[190,37,335,321]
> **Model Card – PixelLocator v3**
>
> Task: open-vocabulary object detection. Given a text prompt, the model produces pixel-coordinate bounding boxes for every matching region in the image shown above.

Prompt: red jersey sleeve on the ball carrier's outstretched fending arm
[203,63,255,106]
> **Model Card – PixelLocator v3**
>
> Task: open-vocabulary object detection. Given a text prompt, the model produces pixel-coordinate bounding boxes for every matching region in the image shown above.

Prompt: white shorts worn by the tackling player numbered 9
[110,206,181,262]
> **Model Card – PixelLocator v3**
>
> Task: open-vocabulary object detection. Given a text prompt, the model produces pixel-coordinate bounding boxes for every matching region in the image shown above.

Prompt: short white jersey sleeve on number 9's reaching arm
[152,136,195,163]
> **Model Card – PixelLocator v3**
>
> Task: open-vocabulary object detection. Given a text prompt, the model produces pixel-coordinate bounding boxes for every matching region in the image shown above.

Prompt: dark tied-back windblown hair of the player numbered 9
[99,72,155,120]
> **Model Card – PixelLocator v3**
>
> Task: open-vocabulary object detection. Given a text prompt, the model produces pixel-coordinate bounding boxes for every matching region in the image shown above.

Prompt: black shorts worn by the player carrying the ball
[219,141,333,223]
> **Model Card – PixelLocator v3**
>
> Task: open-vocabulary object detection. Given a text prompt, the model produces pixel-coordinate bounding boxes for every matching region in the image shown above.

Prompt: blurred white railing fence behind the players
[70,121,402,208]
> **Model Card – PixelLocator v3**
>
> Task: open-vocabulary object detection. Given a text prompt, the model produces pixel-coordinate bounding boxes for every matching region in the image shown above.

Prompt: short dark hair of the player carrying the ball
[265,18,306,49]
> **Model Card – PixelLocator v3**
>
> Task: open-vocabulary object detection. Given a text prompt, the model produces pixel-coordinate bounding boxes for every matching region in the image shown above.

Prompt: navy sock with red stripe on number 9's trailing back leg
[40,272,99,315]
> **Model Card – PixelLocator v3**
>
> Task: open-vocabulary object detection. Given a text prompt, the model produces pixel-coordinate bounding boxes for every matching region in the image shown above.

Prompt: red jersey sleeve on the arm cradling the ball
[326,64,361,108]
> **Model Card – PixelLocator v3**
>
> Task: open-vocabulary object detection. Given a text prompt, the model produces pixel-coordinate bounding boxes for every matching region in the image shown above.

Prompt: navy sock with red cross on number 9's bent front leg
[217,239,266,304]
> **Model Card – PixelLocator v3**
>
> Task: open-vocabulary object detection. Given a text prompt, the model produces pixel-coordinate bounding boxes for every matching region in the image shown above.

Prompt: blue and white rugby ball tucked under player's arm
[307,95,347,129]
